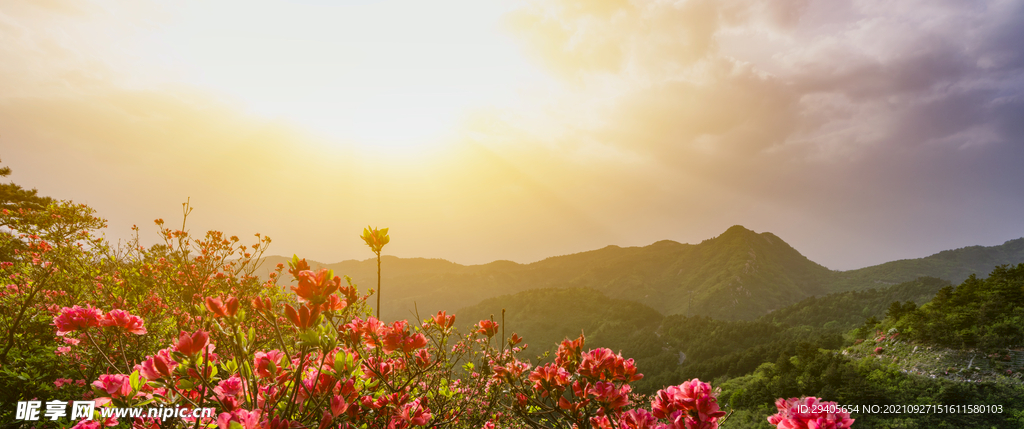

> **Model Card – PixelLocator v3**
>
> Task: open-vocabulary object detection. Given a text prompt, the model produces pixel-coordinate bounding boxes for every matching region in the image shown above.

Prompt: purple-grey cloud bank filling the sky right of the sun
[495,0,1024,266]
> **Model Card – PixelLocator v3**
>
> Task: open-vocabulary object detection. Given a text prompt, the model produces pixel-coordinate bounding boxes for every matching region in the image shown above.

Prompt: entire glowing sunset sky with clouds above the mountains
[0,0,1024,269]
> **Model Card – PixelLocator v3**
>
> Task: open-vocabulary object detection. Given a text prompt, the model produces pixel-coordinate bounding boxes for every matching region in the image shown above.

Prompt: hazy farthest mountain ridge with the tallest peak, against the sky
[256,225,1024,319]
